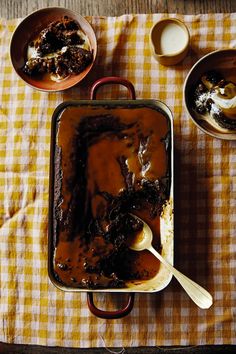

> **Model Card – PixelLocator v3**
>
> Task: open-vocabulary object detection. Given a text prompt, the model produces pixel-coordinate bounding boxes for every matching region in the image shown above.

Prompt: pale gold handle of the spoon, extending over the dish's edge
[148,246,213,309]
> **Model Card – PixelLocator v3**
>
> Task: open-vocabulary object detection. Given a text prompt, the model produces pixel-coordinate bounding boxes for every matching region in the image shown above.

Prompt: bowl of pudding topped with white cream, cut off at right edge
[183,48,236,140]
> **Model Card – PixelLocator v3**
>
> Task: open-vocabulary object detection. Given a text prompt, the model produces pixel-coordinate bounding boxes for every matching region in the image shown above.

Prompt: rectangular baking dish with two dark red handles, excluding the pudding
[48,78,174,318]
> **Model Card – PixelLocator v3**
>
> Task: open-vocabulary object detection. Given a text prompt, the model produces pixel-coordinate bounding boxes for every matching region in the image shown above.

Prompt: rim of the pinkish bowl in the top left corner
[9,6,97,92]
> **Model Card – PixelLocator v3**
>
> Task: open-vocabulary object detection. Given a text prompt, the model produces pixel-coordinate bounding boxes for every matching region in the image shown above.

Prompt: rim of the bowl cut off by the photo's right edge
[182,47,236,141]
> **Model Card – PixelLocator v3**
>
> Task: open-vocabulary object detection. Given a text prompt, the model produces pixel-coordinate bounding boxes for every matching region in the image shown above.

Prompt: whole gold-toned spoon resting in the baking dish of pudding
[129,214,213,309]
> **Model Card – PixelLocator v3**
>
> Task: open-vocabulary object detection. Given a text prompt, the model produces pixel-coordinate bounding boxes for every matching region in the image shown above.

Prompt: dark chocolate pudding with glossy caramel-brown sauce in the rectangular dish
[53,104,171,289]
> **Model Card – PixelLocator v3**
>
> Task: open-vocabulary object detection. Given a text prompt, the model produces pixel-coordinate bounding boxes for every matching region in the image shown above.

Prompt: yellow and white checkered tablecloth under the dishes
[0,13,236,347]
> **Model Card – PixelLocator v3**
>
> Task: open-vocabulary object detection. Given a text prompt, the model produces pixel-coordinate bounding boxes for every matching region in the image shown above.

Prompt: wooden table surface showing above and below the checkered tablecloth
[0,0,236,354]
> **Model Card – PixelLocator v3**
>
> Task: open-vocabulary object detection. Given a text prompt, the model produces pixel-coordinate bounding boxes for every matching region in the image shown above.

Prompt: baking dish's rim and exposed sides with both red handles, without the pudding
[48,77,174,319]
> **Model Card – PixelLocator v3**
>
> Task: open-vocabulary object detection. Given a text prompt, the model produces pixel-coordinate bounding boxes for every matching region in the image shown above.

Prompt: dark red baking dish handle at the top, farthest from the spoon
[90,76,136,100]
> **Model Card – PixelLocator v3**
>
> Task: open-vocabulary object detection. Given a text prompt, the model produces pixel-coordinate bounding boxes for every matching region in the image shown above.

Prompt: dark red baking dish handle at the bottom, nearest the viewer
[87,292,134,320]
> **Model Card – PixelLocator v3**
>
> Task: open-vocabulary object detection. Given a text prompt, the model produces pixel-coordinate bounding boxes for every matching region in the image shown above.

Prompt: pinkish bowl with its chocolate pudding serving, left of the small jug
[10,7,97,91]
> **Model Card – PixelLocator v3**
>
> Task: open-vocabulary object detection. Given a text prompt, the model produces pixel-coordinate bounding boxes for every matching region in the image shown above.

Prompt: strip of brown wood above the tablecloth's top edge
[0,0,236,19]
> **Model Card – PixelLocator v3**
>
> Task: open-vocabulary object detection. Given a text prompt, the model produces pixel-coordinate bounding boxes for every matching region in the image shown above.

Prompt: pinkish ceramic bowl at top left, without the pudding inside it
[10,7,97,91]
